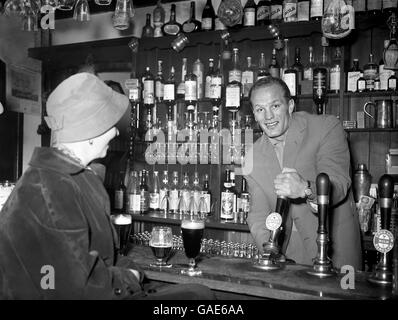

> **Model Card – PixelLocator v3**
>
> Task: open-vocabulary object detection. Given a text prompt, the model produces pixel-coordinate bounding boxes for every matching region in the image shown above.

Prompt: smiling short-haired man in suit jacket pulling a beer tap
[244,77,362,269]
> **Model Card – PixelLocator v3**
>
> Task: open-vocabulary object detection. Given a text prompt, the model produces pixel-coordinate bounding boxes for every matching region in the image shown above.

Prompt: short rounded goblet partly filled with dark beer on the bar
[149,226,173,268]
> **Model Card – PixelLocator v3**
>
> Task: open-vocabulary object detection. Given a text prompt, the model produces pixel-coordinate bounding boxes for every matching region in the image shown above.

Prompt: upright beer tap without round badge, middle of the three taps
[307,173,335,278]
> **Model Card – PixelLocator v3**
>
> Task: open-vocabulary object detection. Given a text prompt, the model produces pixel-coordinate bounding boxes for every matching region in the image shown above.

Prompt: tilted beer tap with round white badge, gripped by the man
[254,196,289,270]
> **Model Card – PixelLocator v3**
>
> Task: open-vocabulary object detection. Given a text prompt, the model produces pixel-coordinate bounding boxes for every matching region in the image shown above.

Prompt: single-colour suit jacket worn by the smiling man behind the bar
[243,112,362,269]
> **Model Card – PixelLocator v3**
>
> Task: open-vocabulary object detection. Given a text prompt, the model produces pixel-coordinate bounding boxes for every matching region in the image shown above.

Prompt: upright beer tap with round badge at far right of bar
[368,174,394,285]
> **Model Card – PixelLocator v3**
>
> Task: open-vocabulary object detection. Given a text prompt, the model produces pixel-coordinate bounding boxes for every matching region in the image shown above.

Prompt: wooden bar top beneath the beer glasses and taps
[129,244,392,300]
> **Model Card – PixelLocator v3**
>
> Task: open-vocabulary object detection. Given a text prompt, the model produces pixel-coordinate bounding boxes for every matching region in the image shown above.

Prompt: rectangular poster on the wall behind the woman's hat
[6,65,41,115]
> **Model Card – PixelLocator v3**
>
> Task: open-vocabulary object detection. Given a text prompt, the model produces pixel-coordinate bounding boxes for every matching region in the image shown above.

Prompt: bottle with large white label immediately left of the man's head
[225,48,242,112]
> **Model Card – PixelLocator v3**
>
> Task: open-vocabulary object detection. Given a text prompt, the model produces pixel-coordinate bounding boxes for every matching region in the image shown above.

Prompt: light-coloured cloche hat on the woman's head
[45,72,129,143]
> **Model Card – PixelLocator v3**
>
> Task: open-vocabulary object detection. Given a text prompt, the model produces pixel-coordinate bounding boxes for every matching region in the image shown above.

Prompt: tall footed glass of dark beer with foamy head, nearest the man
[181,215,205,276]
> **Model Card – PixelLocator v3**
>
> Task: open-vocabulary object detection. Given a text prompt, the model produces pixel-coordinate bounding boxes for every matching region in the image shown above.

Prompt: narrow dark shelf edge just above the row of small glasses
[126,212,250,232]
